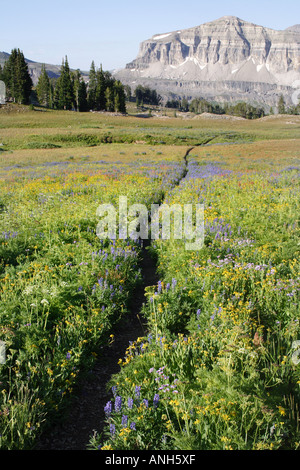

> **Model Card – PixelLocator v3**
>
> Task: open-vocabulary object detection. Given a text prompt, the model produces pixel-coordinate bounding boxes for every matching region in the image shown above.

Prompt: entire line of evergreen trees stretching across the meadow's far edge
[0,49,300,119]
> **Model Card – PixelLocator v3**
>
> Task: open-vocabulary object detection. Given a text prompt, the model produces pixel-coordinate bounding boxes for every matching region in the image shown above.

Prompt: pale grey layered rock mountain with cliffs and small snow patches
[115,16,300,106]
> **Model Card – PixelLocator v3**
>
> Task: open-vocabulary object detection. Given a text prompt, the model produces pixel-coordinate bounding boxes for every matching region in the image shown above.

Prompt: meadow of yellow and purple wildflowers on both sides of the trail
[0,107,300,450]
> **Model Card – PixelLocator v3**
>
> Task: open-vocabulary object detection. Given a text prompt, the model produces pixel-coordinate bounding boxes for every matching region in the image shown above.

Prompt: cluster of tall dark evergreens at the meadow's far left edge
[0,49,126,113]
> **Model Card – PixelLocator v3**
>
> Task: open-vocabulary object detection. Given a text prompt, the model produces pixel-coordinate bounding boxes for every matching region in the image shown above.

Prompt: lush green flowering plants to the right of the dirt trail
[91,157,300,450]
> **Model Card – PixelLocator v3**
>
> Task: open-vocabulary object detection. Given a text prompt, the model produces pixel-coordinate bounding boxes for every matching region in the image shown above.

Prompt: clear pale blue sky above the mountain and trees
[0,0,300,71]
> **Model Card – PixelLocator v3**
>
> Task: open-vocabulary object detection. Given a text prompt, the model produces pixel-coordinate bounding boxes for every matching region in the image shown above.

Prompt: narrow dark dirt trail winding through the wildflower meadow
[35,137,214,450]
